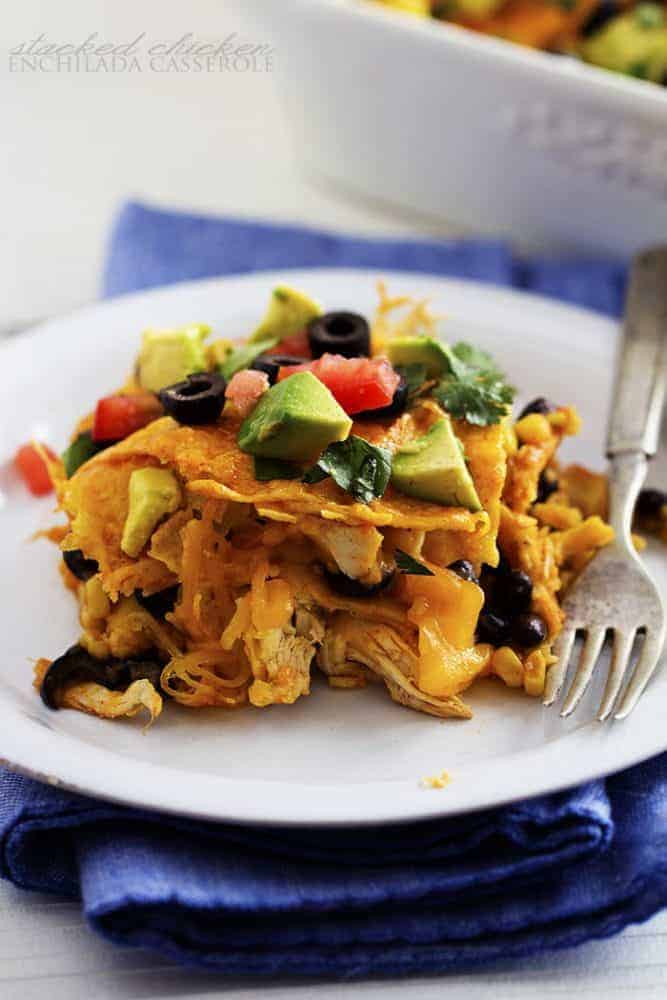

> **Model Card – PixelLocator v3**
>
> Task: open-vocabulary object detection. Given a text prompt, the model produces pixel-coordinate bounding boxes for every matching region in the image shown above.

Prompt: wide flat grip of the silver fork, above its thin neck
[607,247,667,458]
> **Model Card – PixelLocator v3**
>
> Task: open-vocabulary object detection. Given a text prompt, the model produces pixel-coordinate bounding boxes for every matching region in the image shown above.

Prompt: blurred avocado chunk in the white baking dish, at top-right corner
[581,3,667,83]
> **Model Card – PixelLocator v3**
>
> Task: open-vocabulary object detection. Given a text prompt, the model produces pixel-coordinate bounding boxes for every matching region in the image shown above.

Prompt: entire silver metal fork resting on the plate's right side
[544,247,667,721]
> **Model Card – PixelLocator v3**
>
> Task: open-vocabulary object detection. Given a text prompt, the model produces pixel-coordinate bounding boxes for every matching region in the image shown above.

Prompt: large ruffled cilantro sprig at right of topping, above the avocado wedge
[433,343,514,427]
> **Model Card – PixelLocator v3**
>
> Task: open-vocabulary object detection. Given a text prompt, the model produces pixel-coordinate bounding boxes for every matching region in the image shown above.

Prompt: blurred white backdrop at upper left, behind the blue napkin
[0,0,468,326]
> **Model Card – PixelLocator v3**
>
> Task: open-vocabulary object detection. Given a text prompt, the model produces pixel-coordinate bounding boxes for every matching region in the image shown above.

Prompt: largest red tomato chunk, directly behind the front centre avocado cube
[278,354,400,415]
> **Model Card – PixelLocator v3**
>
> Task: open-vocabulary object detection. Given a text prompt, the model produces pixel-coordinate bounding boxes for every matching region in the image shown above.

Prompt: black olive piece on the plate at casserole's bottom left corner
[39,645,162,709]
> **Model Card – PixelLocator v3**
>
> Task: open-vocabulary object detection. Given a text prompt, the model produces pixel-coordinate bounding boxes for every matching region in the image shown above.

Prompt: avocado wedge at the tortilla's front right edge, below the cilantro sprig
[391,417,482,511]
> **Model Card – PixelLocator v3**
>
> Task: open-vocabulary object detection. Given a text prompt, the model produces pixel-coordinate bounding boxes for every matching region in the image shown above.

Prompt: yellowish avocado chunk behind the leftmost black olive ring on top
[137,323,211,392]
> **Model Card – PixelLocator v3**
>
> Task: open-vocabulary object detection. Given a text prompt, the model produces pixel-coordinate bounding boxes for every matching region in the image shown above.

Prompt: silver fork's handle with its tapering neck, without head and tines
[607,247,667,555]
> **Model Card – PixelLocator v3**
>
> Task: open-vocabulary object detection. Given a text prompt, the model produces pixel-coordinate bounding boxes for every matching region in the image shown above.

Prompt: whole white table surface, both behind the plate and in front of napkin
[0,0,667,1000]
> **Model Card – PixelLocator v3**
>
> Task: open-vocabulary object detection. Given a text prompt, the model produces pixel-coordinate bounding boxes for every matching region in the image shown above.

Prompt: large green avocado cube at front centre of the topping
[238,372,352,462]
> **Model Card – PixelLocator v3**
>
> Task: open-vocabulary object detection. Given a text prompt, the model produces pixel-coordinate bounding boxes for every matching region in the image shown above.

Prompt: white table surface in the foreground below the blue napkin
[0,882,667,1000]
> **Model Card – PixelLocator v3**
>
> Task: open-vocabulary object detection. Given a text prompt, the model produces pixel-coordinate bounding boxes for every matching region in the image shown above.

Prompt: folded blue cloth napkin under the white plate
[0,204,667,977]
